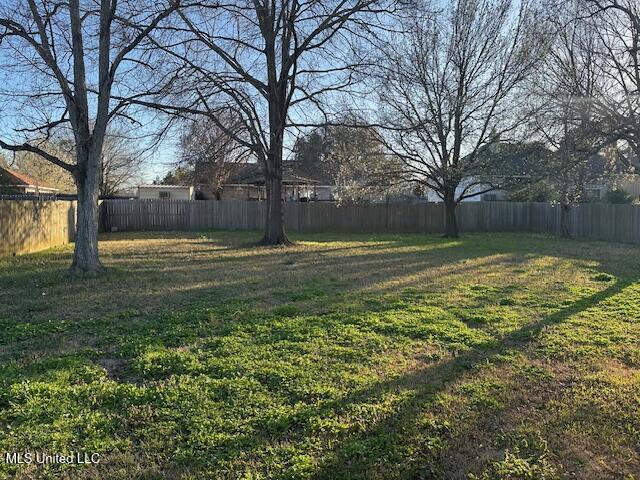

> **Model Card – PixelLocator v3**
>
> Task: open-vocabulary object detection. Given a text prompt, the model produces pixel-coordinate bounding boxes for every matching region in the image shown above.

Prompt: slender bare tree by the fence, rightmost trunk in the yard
[533,0,618,237]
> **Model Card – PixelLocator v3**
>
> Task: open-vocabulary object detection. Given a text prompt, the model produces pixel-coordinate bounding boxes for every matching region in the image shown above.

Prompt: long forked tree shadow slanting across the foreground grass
[99,270,636,479]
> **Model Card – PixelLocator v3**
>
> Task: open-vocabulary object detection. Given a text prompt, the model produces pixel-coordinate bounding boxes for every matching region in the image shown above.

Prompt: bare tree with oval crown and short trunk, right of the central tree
[379,0,546,237]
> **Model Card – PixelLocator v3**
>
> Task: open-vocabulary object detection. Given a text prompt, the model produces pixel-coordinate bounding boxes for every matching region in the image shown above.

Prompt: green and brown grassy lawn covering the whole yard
[0,232,640,480]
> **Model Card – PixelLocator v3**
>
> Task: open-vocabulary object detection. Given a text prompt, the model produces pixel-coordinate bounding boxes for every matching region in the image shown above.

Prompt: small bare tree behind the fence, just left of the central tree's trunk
[179,114,250,200]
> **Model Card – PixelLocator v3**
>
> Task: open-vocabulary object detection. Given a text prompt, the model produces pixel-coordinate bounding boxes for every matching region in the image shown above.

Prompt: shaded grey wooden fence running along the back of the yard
[101,200,640,244]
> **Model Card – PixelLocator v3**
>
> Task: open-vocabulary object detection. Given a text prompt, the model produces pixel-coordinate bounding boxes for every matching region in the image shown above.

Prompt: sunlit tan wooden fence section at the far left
[0,200,76,255]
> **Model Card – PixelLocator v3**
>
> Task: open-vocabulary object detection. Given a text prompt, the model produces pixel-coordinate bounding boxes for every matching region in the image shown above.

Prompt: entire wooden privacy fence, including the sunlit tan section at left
[0,200,640,255]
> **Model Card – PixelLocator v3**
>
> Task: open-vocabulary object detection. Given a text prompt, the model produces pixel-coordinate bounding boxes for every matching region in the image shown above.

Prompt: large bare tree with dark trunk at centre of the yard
[118,0,393,245]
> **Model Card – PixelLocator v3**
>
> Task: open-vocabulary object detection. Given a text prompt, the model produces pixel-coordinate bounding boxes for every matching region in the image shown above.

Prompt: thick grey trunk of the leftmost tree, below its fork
[70,148,103,274]
